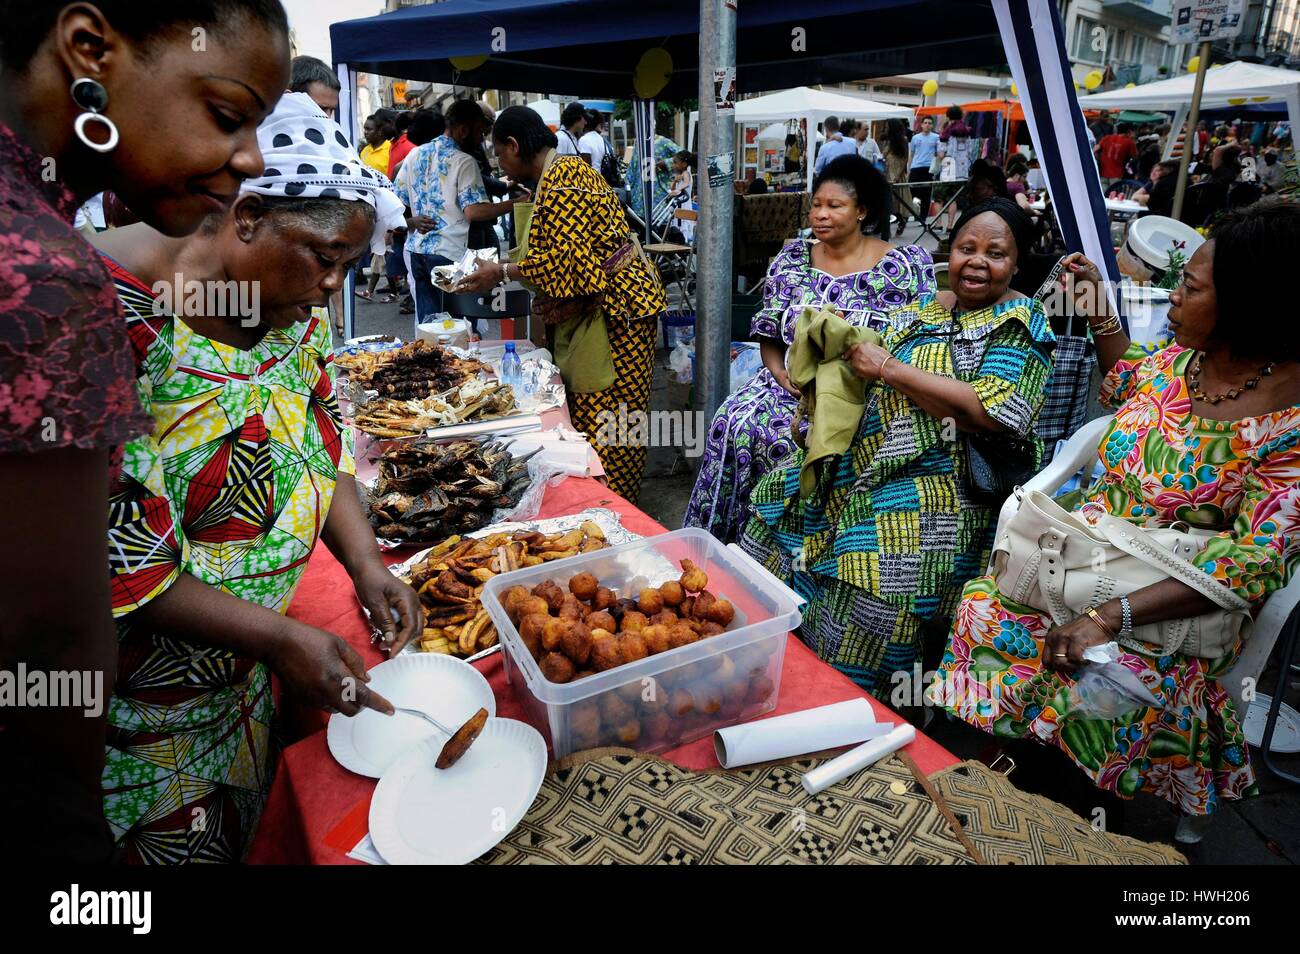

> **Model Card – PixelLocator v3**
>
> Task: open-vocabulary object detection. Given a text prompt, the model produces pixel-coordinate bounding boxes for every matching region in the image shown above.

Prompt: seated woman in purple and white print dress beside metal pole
[683,156,935,542]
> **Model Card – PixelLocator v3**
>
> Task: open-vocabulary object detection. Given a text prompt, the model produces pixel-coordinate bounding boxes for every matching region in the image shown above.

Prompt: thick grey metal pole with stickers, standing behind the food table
[696,0,736,419]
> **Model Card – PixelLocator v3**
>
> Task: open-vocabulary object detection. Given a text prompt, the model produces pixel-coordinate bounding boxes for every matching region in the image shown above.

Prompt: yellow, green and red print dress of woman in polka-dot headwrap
[103,261,354,863]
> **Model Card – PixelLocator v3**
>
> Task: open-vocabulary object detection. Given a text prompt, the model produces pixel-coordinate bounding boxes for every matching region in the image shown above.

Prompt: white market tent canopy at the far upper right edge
[1079,61,1300,153]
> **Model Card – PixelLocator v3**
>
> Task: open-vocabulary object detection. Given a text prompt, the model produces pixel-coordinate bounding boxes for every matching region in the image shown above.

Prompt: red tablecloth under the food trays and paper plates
[248,478,957,864]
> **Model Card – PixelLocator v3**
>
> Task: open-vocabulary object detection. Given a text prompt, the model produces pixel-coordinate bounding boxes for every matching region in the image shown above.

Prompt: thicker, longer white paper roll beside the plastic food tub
[714,698,892,768]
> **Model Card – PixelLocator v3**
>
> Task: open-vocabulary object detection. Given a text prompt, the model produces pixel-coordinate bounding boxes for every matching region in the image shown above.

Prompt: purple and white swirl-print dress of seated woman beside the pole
[683,239,935,542]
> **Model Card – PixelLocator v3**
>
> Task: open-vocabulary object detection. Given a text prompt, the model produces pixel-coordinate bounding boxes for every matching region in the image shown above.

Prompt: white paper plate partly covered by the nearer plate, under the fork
[325,652,497,779]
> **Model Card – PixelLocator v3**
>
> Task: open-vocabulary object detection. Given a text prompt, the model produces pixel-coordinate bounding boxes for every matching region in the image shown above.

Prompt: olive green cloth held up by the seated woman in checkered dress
[789,305,881,496]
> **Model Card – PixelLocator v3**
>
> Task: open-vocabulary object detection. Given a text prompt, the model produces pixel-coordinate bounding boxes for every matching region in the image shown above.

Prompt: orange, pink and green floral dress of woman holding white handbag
[935,346,1300,815]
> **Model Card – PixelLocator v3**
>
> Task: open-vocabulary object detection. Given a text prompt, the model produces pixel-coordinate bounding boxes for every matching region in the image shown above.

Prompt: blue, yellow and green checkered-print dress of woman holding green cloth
[741,296,1053,695]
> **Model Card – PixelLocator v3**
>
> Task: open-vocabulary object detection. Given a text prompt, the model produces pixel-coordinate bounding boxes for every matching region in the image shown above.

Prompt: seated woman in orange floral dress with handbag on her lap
[936,200,1300,821]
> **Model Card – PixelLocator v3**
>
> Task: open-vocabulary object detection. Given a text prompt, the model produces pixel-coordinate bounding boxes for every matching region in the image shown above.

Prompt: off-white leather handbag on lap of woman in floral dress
[992,490,1251,659]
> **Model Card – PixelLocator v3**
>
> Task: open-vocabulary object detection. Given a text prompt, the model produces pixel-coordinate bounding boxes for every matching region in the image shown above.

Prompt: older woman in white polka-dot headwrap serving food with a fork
[99,94,420,862]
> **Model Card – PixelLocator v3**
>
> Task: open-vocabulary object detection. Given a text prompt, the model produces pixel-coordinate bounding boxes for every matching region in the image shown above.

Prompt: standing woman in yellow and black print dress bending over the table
[460,107,667,503]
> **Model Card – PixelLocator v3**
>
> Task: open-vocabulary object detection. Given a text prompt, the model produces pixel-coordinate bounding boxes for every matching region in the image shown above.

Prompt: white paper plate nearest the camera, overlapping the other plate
[371,719,546,864]
